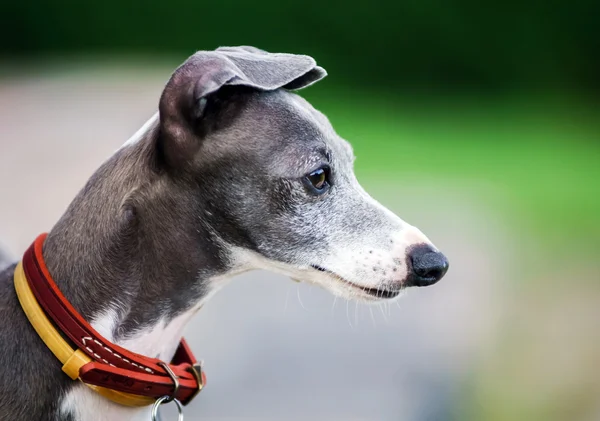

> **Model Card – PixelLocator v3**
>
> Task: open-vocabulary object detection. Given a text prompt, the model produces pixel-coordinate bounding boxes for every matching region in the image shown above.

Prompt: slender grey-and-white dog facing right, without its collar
[0,46,448,421]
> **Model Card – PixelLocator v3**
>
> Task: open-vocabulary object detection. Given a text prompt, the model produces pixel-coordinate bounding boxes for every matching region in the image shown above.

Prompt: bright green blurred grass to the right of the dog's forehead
[305,89,600,270]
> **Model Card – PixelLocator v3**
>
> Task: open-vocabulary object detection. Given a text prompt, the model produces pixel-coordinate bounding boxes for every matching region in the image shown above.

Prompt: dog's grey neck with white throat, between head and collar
[44,120,240,359]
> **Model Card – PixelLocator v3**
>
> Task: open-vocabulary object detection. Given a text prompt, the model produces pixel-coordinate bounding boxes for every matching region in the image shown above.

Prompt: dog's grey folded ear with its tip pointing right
[159,46,327,166]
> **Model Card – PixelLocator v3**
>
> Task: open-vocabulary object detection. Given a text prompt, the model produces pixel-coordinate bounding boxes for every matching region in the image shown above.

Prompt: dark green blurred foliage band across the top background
[0,0,600,93]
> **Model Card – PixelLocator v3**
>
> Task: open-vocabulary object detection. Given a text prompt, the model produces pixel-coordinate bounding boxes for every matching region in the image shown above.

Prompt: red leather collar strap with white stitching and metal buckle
[22,234,206,405]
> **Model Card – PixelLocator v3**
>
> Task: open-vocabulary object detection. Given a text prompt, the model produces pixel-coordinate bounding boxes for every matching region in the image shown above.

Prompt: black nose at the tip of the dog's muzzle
[406,244,448,287]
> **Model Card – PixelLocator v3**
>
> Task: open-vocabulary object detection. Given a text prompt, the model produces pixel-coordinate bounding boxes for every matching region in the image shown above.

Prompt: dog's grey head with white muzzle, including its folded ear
[159,47,448,300]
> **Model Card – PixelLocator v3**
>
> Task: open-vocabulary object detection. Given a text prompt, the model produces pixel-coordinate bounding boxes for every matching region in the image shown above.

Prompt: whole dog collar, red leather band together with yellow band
[14,234,206,410]
